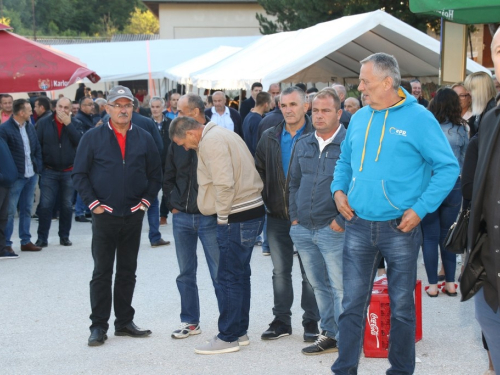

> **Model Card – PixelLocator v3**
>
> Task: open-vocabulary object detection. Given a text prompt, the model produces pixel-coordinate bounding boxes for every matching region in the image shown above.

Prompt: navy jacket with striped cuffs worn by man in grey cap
[72,123,162,216]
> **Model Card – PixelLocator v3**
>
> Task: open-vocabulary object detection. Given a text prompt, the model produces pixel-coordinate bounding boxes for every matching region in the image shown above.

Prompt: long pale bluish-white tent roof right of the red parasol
[53,36,262,82]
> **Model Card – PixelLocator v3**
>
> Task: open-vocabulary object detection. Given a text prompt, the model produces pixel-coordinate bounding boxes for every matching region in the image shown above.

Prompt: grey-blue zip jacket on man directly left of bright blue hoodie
[289,125,346,230]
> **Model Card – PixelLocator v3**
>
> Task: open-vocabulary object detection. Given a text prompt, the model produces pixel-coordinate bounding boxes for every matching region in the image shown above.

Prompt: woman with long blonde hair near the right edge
[464,72,497,137]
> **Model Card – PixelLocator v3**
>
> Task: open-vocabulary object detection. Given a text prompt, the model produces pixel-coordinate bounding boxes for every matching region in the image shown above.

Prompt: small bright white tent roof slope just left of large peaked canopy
[165,46,241,85]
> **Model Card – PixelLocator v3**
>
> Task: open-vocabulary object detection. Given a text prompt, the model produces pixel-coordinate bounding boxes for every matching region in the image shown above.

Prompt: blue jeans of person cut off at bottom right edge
[474,288,500,372]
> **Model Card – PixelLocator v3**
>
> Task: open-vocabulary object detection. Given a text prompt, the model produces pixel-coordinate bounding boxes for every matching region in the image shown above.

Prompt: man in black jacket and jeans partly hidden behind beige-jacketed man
[163,94,219,339]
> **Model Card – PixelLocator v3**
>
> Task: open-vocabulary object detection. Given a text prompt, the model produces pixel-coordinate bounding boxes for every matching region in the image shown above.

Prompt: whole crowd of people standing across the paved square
[0,31,500,375]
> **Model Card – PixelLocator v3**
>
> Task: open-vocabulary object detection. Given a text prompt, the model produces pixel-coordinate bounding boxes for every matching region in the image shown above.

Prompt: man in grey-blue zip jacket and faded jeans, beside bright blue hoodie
[289,88,346,355]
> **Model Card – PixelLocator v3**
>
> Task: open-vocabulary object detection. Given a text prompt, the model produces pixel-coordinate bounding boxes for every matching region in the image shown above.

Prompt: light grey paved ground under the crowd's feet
[0,216,487,375]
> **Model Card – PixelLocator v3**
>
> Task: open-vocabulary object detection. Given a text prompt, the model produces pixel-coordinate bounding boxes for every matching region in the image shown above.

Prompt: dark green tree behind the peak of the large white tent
[256,0,439,34]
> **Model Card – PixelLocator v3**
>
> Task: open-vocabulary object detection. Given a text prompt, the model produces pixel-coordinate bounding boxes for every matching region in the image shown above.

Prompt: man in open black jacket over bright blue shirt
[255,86,319,342]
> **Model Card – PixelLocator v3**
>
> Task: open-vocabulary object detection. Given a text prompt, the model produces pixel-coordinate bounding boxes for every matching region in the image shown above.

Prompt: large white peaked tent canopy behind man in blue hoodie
[191,10,488,89]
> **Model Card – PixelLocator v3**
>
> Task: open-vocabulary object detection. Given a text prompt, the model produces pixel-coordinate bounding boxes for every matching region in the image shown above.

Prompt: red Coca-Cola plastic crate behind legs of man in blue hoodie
[363,279,422,358]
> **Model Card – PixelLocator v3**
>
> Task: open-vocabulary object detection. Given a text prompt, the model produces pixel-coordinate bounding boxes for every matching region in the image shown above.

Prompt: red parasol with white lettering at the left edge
[0,23,101,93]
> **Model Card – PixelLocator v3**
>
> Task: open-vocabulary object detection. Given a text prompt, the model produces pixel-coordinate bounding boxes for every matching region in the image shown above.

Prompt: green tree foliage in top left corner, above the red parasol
[3,0,146,36]
